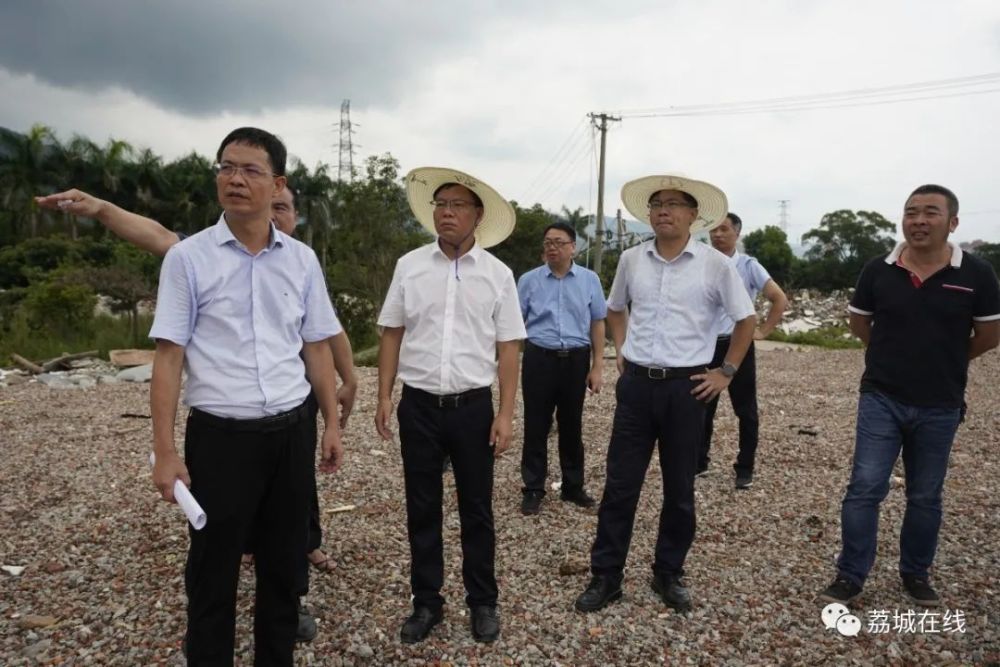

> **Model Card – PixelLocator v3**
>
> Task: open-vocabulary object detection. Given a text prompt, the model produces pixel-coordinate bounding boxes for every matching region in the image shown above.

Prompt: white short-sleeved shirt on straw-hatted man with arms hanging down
[378,241,525,395]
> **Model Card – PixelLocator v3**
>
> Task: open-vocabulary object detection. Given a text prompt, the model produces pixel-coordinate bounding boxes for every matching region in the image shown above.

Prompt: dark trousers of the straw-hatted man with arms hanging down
[396,385,497,609]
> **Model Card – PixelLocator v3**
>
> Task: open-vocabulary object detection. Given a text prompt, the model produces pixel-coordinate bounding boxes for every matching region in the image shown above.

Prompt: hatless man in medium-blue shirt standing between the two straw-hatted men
[517,222,608,515]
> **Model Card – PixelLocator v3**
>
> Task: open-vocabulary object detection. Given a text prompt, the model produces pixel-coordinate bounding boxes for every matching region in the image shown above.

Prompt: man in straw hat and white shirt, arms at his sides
[375,167,525,644]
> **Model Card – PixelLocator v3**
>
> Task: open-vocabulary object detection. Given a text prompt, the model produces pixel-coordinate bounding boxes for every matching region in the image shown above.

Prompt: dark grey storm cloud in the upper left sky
[0,0,516,114]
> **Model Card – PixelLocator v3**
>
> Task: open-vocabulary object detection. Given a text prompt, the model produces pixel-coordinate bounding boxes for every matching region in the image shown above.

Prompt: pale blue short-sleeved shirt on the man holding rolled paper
[149,216,343,419]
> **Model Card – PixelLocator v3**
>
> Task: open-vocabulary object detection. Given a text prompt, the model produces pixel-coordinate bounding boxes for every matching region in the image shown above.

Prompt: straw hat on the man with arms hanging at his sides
[406,167,516,248]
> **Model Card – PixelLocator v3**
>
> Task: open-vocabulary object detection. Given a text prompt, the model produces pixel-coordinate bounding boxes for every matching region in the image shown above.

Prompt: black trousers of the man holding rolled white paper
[184,402,316,665]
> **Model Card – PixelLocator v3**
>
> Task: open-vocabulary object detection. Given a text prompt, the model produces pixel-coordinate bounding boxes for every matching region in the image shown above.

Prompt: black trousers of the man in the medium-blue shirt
[521,343,590,495]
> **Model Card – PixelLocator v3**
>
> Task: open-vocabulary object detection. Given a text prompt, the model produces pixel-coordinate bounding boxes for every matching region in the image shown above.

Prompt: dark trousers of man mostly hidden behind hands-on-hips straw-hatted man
[698,337,760,472]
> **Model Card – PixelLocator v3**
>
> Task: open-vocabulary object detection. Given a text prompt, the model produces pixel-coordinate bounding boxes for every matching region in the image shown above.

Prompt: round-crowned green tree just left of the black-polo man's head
[796,209,896,290]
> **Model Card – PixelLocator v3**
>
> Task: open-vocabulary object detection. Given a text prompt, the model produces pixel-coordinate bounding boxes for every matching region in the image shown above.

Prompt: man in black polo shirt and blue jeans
[820,185,1000,607]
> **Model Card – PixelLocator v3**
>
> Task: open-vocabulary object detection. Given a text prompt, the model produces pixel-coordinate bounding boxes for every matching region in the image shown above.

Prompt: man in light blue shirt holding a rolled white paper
[150,128,342,665]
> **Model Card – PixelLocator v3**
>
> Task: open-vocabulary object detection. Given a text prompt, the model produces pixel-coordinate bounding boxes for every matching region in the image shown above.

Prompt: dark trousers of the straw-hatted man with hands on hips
[590,374,705,577]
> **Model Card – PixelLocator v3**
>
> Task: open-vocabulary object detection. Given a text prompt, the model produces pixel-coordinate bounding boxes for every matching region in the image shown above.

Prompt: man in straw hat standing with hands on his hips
[576,176,756,612]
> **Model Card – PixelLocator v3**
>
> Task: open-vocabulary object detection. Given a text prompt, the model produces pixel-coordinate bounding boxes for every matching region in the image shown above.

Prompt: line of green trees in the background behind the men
[0,125,1000,363]
